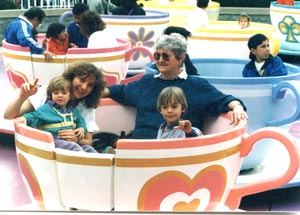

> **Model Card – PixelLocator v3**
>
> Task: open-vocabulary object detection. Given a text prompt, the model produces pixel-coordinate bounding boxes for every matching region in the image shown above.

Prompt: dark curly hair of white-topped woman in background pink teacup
[79,11,106,37]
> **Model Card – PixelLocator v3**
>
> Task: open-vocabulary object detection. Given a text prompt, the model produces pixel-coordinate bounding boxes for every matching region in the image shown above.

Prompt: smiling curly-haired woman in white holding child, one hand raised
[4,62,106,145]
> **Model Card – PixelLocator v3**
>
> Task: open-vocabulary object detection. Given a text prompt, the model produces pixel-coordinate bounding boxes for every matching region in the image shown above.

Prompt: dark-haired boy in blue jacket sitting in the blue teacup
[243,34,287,77]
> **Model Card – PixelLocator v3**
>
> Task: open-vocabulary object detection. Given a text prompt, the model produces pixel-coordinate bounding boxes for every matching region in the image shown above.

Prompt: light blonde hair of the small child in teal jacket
[47,76,72,100]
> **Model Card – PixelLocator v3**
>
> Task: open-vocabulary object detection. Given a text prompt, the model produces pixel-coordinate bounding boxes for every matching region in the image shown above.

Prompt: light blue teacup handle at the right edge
[266,80,300,126]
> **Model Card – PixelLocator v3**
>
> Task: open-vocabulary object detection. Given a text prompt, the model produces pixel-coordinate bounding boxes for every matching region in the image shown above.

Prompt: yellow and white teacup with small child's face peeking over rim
[188,21,280,59]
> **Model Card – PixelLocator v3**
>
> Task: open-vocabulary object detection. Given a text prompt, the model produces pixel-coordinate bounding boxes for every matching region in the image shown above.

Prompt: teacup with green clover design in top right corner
[270,1,300,56]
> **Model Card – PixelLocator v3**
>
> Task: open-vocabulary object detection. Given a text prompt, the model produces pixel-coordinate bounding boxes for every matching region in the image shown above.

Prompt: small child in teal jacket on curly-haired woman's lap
[16,76,97,153]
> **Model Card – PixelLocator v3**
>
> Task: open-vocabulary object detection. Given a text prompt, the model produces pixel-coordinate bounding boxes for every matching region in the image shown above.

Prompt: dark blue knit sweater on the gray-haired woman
[109,74,242,139]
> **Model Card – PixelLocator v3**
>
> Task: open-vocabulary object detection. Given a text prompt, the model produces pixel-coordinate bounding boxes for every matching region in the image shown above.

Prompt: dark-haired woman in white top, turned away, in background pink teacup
[79,11,118,48]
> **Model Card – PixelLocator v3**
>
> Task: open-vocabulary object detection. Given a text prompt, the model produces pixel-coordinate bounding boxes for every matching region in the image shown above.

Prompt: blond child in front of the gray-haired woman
[157,87,202,139]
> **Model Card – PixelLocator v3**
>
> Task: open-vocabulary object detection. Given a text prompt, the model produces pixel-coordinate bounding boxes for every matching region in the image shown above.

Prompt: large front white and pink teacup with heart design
[15,98,299,212]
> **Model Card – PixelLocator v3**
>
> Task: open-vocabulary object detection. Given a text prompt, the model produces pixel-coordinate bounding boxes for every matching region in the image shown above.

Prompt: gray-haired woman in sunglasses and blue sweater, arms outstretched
[105,34,248,139]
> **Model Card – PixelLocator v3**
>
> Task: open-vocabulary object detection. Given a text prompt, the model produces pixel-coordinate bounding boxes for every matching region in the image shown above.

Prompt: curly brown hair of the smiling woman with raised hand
[62,61,106,108]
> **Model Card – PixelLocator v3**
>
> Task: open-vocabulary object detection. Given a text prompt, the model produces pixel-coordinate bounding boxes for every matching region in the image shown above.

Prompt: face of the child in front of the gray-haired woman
[160,100,184,125]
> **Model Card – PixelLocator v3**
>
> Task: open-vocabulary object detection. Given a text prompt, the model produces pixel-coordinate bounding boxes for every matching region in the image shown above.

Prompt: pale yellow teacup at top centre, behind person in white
[138,0,220,27]
